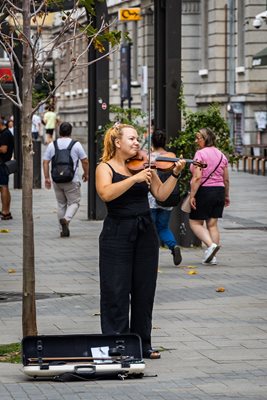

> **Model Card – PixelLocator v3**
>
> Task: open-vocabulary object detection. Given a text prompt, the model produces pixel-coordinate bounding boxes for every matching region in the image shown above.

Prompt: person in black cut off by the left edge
[0,118,14,220]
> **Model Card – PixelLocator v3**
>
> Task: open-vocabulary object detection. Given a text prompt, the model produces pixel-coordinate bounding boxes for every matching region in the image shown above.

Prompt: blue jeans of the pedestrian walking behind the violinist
[150,208,177,250]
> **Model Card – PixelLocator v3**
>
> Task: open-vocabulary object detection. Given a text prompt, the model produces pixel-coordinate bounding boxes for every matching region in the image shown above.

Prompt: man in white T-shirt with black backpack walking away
[43,122,88,237]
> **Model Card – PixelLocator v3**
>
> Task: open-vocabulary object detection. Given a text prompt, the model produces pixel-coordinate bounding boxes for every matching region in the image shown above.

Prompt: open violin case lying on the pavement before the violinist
[21,334,145,380]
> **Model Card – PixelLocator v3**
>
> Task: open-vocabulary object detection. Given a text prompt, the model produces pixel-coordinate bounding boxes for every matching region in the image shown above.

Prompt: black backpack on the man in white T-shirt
[51,140,79,183]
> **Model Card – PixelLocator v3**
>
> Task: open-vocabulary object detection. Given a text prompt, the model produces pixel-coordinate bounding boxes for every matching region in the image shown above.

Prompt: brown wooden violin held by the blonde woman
[126,150,207,174]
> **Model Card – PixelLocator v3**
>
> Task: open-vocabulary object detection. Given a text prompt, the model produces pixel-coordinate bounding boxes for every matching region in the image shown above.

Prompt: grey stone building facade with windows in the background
[52,0,267,147]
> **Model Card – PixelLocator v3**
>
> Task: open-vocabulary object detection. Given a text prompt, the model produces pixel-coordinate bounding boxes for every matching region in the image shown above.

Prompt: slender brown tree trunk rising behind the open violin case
[21,0,37,336]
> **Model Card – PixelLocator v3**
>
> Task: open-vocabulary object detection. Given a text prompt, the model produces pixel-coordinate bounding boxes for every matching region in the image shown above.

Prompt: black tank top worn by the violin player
[106,163,149,217]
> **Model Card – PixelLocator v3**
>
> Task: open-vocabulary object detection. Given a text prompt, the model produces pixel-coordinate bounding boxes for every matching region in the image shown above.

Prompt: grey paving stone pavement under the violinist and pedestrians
[0,167,267,400]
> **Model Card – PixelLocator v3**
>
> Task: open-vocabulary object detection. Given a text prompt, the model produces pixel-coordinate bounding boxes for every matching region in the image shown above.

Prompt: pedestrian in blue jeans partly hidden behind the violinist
[148,129,182,265]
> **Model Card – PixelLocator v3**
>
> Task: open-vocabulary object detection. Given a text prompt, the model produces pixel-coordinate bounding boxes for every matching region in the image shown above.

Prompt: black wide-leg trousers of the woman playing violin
[99,216,159,350]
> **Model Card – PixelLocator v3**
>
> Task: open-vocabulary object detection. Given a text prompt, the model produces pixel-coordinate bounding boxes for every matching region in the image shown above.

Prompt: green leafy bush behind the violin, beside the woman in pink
[170,101,239,196]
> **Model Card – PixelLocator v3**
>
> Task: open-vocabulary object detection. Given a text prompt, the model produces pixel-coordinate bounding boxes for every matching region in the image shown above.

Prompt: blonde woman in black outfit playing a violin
[96,123,185,359]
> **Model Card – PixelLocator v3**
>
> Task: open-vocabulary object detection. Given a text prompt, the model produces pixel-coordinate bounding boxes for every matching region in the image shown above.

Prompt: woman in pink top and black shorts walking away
[189,128,230,264]
